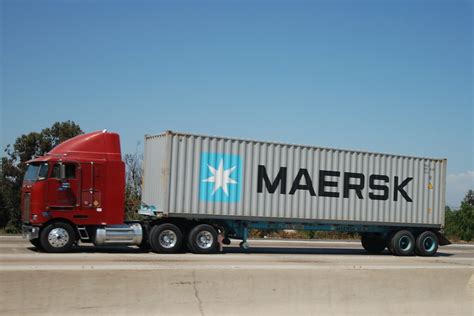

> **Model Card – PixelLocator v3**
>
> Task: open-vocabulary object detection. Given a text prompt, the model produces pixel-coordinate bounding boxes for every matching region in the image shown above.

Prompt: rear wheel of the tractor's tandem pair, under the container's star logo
[188,224,219,254]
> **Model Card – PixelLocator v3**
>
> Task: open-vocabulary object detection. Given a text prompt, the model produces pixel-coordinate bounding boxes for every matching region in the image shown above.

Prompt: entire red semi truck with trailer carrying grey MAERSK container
[21,130,449,256]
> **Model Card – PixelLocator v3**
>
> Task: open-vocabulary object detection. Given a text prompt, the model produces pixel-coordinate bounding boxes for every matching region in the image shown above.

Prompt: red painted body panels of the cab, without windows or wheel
[22,131,125,225]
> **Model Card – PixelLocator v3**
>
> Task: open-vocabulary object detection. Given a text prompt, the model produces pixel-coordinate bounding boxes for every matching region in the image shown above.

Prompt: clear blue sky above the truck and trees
[0,0,474,206]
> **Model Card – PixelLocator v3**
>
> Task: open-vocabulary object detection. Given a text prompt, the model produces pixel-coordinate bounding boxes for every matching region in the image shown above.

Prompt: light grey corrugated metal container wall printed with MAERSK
[143,133,446,226]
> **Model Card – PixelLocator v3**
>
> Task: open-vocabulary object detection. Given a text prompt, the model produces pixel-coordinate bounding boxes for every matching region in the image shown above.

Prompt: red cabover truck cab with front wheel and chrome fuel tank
[21,131,143,252]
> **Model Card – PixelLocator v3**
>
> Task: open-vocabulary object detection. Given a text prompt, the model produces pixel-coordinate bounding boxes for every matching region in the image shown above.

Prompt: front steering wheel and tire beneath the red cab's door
[39,222,76,253]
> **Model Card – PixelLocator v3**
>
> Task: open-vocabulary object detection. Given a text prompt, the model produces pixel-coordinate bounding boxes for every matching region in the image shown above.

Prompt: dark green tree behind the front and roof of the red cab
[0,121,83,231]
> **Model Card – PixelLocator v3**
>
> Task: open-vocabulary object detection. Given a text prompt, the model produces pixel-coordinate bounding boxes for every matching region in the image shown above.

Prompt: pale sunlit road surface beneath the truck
[0,236,474,316]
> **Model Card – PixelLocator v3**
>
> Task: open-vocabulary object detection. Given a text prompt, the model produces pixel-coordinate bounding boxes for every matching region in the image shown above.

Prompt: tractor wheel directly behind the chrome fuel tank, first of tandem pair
[148,223,183,253]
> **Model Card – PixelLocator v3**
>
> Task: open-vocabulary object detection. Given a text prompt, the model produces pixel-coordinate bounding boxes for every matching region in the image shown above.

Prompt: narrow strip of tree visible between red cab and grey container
[124,143,143,220]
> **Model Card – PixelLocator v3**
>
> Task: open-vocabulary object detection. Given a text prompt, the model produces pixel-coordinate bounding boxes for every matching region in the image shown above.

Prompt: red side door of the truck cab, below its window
[46,163,80,209]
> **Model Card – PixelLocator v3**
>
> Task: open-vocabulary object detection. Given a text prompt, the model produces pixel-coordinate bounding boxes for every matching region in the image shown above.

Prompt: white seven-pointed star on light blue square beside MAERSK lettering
[199,153,242,202]
